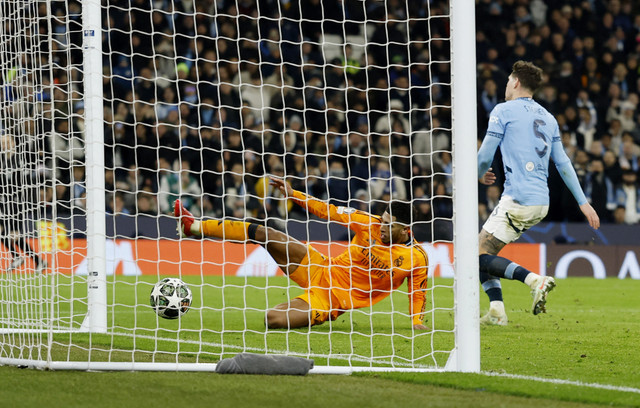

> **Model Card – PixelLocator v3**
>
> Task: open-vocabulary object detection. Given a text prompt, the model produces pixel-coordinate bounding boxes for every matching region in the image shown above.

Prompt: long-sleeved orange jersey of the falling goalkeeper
[291,190,428,324]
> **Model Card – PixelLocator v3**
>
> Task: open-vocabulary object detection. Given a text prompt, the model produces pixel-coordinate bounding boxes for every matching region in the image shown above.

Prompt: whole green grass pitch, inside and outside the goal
[0,277,640,407]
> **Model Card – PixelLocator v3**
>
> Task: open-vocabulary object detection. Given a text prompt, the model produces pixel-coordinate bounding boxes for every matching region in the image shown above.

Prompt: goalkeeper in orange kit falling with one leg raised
[174,177,429,330]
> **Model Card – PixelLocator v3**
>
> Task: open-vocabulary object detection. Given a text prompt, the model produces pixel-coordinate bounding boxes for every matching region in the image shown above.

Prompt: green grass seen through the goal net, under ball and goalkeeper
[3,276,453,367]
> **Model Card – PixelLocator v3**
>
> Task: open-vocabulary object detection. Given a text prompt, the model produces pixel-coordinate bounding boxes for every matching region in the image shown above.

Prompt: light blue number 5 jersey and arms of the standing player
[478,98,587,205]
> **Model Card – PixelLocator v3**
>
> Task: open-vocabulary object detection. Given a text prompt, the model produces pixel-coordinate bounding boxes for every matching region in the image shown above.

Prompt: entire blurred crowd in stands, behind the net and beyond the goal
[7,0,640,239]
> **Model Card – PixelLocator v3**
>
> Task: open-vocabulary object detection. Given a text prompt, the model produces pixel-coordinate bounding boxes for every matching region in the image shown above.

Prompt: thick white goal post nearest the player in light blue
[451,0,480,372]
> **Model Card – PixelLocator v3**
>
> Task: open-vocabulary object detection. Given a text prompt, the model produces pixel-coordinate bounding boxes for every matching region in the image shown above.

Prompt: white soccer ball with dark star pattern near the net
[151,278,193,319]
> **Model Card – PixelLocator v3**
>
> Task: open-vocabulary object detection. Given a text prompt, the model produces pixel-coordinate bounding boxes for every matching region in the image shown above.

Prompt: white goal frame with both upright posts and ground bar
[0,0,480,374]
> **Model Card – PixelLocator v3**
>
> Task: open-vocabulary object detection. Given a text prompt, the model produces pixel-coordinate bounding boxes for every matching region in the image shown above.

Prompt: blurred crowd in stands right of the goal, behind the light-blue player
[476,0,640,224]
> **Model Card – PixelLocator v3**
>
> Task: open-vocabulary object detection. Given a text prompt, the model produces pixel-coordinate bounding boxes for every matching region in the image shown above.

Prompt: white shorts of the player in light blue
[482,196,549,244]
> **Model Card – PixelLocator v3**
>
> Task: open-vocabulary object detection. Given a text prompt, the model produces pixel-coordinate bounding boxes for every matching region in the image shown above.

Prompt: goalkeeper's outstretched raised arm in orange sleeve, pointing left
[271,177,379,231]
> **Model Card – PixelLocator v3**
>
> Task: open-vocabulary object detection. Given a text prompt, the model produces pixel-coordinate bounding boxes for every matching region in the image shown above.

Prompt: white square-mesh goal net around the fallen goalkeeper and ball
[0,0,479,372]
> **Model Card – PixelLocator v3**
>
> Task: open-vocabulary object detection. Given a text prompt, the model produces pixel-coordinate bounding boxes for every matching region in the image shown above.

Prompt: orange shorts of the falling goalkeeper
[289,245,344,325]
